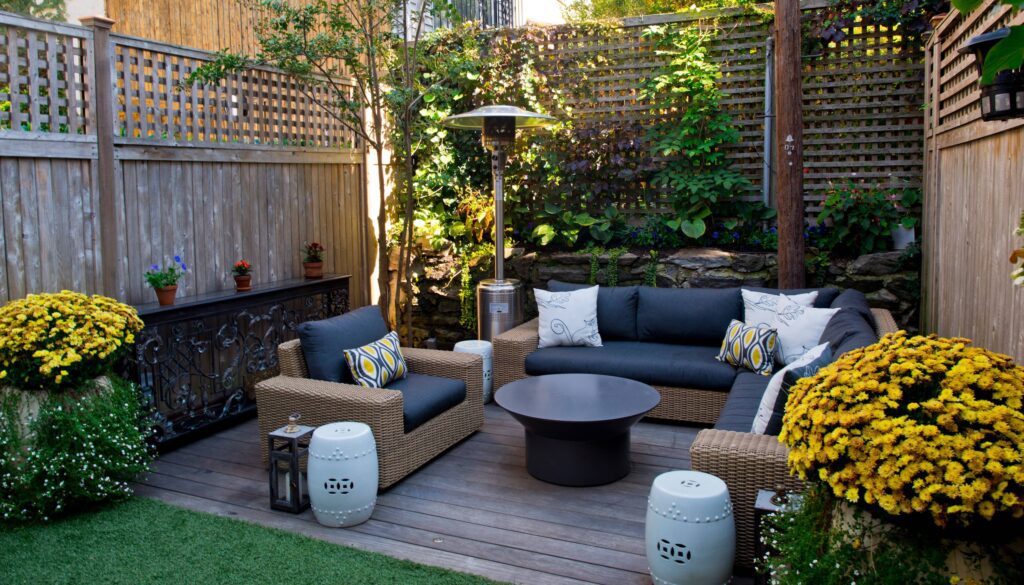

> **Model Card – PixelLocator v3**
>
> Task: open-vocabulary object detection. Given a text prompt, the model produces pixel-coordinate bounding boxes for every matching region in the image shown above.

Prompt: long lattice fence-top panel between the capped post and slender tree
[114,38,357,148]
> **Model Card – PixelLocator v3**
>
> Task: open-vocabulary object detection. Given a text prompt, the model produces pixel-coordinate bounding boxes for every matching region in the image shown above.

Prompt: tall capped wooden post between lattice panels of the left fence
[81,16,125,297]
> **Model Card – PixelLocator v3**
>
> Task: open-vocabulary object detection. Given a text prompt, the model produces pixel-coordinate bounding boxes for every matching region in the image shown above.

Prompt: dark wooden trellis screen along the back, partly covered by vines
[540,2,924,215]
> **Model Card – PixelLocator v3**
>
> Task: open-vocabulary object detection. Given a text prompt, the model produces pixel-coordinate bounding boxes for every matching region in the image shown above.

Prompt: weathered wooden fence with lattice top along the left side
[0,12,375,306]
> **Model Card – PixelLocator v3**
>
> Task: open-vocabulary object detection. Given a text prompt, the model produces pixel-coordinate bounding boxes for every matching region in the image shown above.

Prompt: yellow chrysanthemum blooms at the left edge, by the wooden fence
[0,291,142,389]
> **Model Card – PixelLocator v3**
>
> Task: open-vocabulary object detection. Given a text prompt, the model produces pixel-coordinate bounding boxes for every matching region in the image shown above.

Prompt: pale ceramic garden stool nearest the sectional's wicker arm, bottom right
[646,471,736,585]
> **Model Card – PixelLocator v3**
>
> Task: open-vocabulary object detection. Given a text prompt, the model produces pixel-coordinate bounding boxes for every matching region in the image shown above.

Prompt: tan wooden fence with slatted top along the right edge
[922,0,1024,361]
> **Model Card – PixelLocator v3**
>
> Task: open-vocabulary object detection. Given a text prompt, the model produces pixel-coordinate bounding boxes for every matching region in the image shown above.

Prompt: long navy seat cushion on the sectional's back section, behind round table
[526,341,737,391]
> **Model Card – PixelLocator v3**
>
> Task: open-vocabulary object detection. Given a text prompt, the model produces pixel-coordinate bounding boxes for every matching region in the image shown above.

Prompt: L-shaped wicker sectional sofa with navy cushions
[494,282,897,567]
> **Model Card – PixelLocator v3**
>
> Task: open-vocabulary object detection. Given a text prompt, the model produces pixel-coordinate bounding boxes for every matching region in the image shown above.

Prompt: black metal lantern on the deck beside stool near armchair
[266,415,315,514]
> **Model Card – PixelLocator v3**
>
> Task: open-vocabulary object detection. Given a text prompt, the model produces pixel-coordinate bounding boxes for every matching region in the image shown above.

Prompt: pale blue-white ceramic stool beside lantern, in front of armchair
[307,422,378,528]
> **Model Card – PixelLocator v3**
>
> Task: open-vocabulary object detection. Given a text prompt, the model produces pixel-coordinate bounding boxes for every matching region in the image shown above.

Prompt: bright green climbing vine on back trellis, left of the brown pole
[640,27,750,239]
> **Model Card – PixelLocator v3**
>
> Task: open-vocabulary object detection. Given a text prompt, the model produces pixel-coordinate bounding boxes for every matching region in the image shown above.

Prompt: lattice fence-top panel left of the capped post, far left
[0,14,92,134]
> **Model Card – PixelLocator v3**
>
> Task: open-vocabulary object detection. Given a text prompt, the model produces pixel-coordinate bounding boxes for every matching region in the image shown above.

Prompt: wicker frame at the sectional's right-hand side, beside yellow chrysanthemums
[690,308,899,568]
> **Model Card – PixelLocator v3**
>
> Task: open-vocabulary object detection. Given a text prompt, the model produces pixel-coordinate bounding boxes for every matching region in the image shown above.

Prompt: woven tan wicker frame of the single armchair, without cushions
[256,339,483,490]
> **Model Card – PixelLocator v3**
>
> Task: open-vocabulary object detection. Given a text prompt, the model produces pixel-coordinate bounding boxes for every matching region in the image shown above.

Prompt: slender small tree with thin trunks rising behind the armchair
[185,0,456,336]
